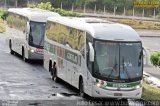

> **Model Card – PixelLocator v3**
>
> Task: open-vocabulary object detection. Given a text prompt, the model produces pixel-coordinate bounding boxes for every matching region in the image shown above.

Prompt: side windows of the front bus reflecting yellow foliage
[46,22,85,51]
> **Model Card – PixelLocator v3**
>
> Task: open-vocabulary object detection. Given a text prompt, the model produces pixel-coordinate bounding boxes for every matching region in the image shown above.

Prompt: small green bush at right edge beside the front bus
[150,52,160,66]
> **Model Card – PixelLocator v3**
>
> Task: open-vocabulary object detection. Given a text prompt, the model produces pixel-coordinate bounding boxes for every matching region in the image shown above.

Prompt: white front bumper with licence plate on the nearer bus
[92,85,142,99]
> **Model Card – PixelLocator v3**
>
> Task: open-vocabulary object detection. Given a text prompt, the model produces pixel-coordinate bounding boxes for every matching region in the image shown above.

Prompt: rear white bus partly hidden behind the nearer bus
[7,8,60,60]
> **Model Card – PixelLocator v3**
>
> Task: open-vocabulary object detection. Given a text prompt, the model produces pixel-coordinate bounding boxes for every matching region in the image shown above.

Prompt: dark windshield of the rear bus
[29,21,45,48]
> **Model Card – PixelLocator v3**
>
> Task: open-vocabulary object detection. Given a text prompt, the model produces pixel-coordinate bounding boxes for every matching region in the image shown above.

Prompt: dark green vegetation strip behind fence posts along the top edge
[0,0,160,18]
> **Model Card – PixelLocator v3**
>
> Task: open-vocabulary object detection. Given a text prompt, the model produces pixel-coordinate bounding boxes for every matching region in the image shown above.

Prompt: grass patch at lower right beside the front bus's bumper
[142,82,160,101]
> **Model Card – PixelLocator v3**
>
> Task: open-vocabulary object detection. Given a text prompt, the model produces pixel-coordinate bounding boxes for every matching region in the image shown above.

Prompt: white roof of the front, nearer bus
[48,17,141,41]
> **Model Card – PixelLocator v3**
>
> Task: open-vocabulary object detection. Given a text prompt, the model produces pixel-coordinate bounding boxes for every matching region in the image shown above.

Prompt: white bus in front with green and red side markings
[44,17,143,98]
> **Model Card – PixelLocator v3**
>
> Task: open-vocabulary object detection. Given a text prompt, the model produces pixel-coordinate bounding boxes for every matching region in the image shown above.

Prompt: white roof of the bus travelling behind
[8,8,60,22]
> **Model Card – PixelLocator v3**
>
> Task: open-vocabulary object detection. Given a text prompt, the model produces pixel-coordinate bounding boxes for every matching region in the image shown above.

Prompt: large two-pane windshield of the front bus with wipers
[94,41,143,81]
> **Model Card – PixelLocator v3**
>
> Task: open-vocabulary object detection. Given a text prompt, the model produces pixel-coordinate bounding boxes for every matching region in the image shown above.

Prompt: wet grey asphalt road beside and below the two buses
[0,34,156,106]
